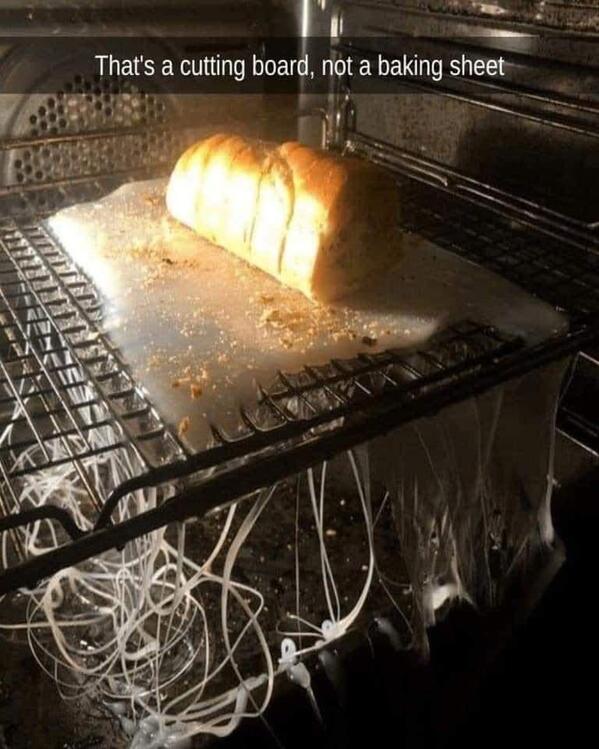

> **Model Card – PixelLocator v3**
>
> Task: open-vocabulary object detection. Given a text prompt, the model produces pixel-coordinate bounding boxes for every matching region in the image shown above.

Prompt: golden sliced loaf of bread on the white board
[166,134,401,301]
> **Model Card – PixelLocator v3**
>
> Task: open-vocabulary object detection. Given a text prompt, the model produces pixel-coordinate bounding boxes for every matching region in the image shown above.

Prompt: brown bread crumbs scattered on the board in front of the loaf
[118,194,397,372]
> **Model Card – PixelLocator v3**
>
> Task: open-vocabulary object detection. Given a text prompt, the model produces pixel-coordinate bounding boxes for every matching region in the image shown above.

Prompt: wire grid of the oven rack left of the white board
[0,207,182,568]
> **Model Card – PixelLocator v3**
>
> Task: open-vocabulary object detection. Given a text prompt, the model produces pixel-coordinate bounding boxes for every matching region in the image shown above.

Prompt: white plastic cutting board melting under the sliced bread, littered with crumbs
[47,180,566,450]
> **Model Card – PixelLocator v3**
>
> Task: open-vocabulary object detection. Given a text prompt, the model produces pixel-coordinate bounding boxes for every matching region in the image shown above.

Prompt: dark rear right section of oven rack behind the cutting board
[348,134,599,325]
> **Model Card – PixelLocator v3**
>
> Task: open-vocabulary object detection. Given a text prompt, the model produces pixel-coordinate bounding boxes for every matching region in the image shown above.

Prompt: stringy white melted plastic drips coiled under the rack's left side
[0,436,382,748]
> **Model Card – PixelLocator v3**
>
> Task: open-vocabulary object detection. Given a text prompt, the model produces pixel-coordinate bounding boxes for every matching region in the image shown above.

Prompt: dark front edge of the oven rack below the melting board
[0,316,590,595]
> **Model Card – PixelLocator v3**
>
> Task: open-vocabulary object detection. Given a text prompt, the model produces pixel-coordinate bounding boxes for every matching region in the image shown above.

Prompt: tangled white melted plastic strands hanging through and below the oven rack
[0,308,398,749]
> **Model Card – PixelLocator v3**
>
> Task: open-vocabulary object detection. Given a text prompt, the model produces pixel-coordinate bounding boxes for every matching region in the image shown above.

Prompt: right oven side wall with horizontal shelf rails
[330,0,599,224]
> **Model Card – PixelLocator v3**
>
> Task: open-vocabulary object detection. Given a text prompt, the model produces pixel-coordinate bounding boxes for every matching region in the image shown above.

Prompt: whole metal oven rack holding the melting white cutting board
[0,154,599,593]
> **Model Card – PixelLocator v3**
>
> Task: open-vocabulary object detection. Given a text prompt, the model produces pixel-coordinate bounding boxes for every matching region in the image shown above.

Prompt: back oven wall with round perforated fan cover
[0,0,297,186]
